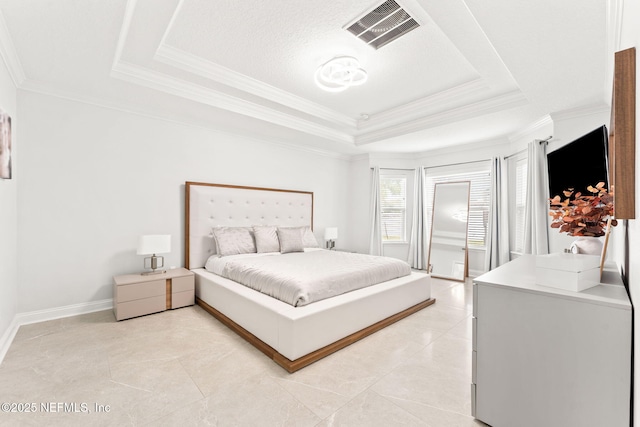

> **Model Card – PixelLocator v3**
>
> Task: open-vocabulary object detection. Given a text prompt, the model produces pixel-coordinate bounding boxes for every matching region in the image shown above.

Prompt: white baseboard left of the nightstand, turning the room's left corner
[0,298,113,363]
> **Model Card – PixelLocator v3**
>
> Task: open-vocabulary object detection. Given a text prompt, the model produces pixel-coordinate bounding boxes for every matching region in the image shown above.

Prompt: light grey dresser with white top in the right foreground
[471,255,632,427]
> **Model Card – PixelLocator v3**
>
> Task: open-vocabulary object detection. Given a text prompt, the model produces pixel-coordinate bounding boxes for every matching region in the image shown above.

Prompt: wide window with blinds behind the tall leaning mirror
[425,162,491,249]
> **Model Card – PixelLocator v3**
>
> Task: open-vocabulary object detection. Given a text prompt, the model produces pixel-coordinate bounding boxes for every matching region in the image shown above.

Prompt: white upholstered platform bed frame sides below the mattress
[192,268,431,361]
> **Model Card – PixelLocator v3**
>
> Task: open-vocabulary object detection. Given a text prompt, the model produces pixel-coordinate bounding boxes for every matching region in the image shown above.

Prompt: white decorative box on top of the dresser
[536,253,600,292]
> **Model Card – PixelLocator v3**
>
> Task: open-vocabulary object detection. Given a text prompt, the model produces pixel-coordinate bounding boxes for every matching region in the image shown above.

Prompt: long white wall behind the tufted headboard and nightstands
[15,92,350,313]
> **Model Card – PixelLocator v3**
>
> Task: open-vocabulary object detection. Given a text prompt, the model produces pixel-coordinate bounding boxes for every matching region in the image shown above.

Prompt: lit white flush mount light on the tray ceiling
[315,56,367,92]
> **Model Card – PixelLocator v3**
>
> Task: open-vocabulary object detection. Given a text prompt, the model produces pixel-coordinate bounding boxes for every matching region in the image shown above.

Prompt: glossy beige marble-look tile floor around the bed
[0,279,484,427]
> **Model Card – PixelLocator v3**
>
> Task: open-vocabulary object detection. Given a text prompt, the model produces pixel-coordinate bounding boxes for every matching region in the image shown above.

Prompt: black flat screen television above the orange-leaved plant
[547,125,610,199]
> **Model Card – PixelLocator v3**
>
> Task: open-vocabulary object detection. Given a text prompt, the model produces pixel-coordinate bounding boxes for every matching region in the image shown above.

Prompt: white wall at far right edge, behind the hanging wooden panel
[611,0,640,425]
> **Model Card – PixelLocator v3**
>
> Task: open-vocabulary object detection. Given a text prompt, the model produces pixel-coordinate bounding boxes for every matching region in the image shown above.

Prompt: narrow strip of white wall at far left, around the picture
[0,55,16,354]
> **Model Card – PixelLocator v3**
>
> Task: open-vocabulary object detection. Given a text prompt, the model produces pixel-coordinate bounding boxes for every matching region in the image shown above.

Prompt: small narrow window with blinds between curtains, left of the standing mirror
[380,175,407,242]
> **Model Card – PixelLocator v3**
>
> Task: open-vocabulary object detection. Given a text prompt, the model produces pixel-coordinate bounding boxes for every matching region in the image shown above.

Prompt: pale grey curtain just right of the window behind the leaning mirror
[484,157,509,271]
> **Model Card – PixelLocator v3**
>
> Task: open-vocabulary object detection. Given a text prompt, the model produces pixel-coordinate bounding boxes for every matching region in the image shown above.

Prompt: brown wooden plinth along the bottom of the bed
[196,297,436,373]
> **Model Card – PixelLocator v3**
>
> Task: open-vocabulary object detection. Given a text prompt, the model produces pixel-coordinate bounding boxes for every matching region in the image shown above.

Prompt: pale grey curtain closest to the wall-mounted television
[524,140,549,255]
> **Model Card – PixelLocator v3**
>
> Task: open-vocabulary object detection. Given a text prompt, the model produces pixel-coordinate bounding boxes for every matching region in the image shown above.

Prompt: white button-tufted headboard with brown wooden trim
[185,182,313,268]
